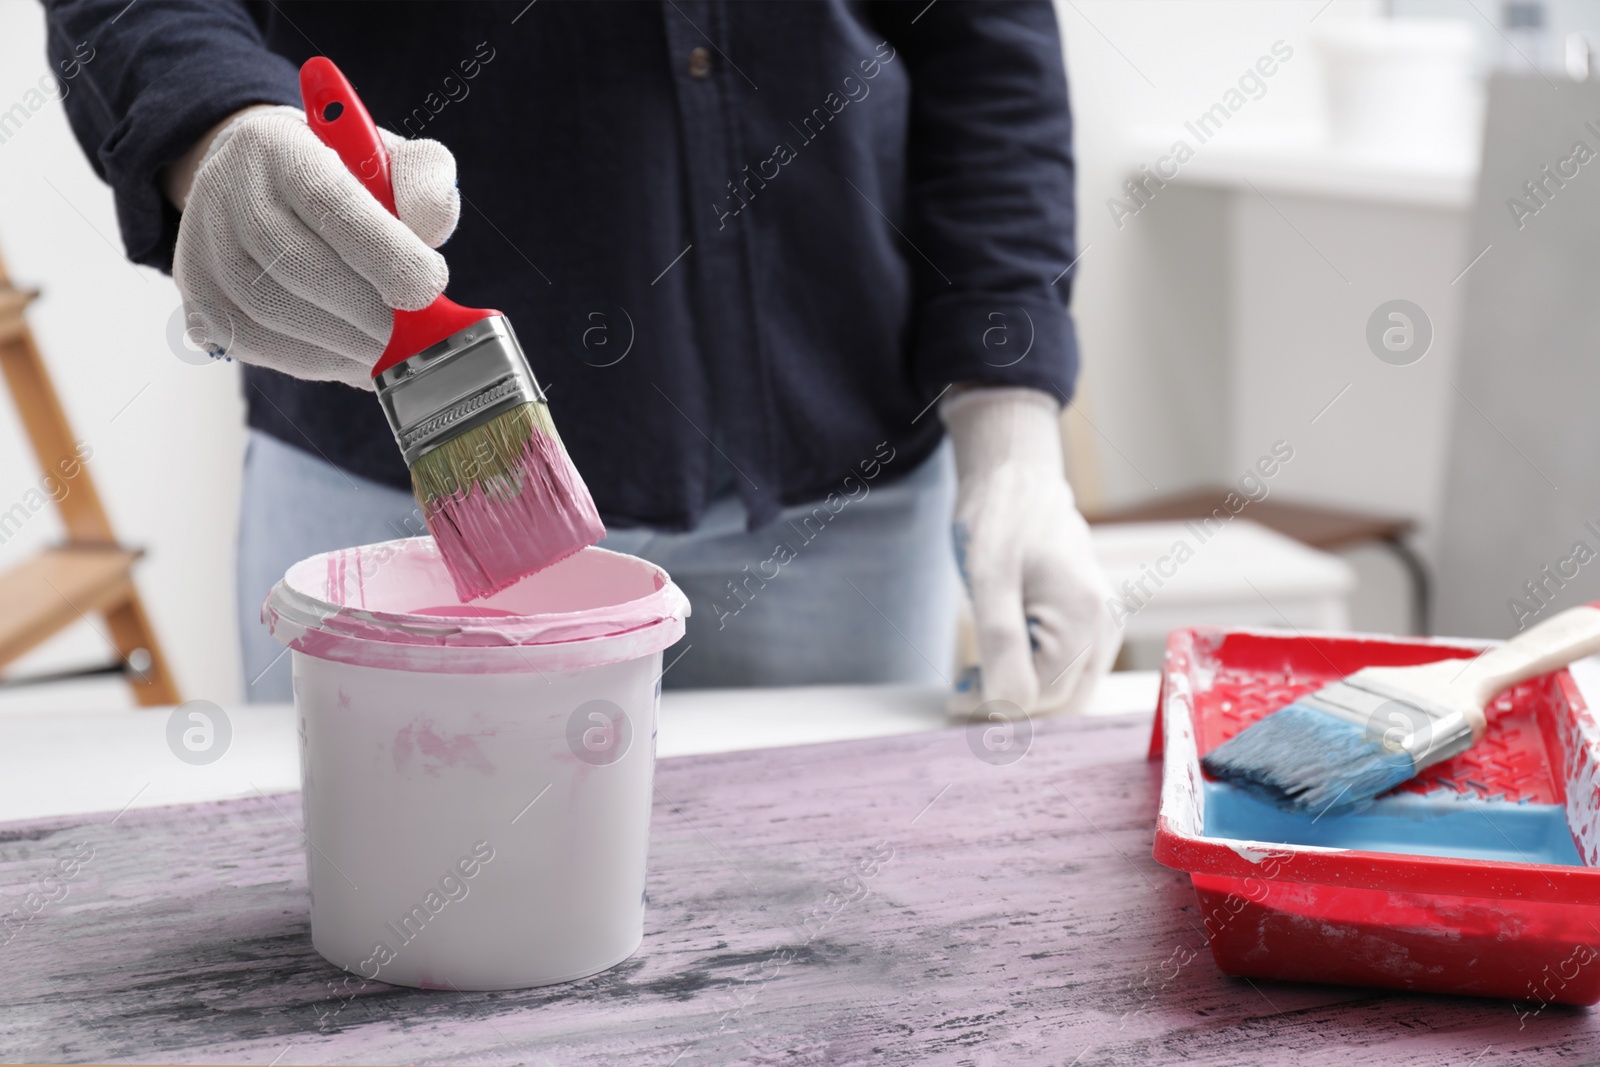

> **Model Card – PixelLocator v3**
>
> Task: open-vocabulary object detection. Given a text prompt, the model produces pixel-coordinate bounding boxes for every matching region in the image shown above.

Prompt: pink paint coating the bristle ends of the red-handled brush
[422,430,605,601]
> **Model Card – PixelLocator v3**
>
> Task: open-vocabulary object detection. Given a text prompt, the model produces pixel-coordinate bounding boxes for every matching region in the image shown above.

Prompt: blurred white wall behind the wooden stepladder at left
[0,8,245,707]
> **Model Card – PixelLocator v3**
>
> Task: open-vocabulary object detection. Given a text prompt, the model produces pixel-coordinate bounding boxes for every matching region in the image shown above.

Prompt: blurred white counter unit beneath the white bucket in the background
[1125,128,1496,629]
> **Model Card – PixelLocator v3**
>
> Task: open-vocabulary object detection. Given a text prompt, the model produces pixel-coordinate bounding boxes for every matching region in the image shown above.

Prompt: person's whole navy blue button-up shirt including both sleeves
[46,0,1077,530]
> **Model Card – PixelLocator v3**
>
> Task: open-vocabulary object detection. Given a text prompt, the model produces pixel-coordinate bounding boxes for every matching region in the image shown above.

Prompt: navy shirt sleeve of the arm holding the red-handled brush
[45,0,299,272]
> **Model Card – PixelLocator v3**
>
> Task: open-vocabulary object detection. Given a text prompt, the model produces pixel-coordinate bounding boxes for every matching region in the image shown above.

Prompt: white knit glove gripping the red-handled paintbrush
[173,107,461,389]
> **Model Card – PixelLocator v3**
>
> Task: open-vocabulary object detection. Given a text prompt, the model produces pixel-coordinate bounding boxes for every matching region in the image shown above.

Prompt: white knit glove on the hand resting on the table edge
[939,387,1122,718]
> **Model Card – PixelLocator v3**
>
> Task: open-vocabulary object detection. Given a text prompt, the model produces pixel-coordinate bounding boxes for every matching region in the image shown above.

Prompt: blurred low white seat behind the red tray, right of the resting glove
[1091,518,1355,641]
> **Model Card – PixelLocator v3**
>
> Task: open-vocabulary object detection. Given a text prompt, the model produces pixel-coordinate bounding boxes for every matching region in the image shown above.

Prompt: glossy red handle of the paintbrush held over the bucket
[301,56,499,378]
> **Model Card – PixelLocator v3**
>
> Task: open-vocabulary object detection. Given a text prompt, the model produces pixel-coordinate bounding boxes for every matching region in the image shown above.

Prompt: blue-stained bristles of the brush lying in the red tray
[1200,704,1416,814]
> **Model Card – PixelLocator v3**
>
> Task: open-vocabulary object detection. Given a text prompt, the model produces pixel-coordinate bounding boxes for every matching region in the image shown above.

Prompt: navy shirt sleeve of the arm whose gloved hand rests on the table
[875,0,1078,402]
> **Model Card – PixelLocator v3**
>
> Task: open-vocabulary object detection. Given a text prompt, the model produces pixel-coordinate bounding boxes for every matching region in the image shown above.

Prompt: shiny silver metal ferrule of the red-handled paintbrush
[373,315,544,467]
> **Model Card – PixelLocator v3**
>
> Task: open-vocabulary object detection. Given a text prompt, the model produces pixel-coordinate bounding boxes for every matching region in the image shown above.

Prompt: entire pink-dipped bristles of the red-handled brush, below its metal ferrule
[411,403,605,601]
